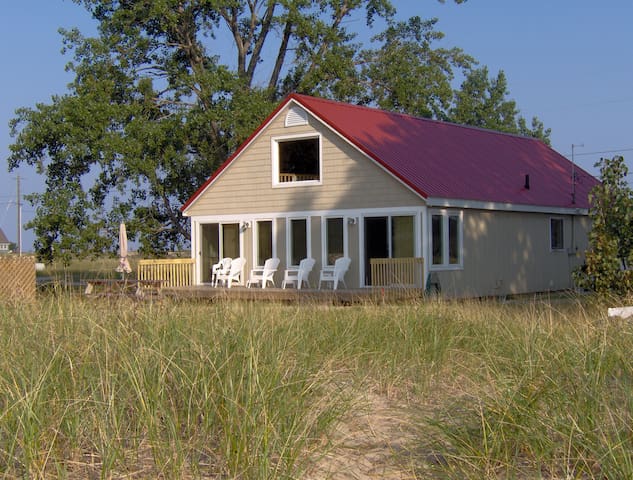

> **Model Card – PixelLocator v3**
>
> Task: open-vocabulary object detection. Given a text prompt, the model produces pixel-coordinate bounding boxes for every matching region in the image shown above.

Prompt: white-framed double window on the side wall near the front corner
[431,211,462,268]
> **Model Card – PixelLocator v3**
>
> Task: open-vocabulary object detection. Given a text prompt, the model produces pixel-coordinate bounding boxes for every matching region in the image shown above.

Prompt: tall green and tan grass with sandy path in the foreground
[0,293,633,479]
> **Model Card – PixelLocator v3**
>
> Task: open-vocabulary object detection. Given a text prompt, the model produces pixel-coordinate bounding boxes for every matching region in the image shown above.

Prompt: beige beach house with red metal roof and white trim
[182,94,598,296]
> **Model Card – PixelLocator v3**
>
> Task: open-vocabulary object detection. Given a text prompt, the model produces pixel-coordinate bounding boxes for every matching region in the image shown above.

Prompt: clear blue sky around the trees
[0,0,633,250]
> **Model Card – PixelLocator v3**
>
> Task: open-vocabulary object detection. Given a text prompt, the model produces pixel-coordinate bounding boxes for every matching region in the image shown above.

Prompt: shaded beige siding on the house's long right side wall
[438,210,589,296]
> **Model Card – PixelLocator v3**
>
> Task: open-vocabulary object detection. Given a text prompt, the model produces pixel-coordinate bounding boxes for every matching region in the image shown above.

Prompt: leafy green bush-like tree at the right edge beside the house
[577,156,633,295]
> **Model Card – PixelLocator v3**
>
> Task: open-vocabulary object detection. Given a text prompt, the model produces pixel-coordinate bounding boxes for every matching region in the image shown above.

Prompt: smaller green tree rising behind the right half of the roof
[448,67,551,145]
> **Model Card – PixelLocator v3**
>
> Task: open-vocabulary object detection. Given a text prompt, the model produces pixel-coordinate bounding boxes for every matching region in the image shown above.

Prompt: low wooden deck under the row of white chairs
[162,285,424,304]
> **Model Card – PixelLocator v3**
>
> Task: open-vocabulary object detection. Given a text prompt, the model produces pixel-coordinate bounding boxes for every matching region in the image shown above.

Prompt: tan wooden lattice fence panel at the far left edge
[0,255,36,300]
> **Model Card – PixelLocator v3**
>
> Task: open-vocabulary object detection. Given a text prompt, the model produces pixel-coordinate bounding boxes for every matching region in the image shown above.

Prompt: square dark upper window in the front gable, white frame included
[273,137,321,185]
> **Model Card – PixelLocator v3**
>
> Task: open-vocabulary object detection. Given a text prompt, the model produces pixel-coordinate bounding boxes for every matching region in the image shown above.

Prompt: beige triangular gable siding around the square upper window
[187,109,422,216]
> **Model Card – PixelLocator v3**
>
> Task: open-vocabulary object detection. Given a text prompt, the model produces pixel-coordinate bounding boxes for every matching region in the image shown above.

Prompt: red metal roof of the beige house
[183,94,598,210]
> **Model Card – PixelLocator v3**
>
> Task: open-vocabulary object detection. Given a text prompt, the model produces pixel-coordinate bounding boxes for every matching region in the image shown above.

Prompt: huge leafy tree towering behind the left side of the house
[9,0,544,260]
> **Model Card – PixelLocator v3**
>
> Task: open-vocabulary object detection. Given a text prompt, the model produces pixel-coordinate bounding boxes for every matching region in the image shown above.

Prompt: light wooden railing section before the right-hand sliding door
[369,257,424,288]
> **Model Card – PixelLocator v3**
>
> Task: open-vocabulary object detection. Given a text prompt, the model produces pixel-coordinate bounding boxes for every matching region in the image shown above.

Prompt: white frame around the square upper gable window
[270,133,323,188]
